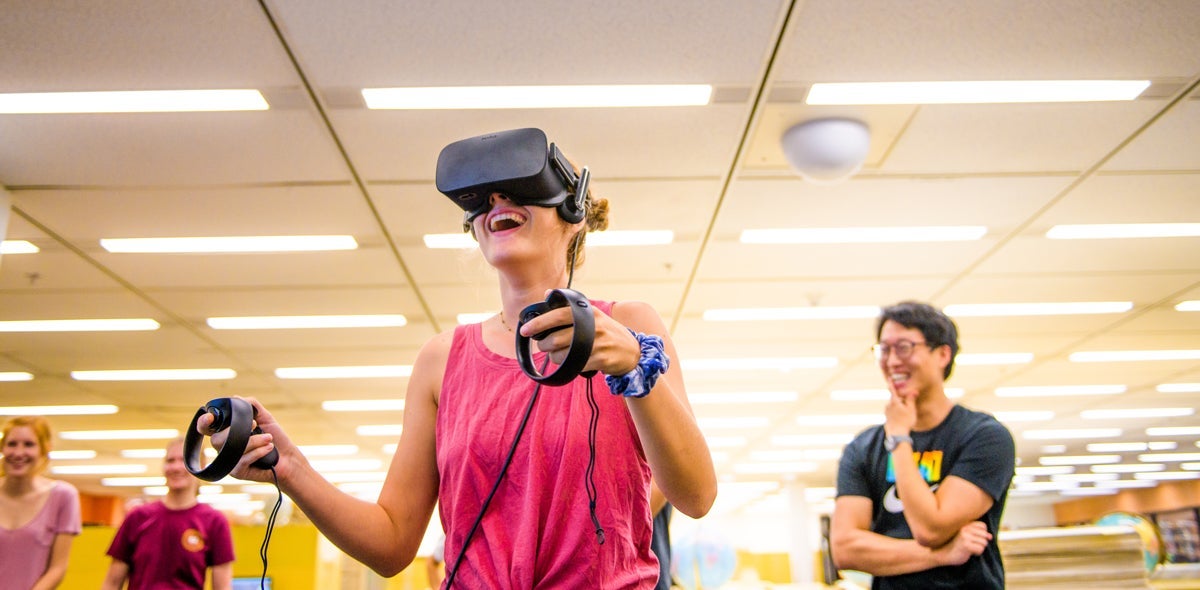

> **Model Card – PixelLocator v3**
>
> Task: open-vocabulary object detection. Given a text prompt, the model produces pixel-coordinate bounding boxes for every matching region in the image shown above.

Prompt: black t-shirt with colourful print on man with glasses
[838,405,1016,590]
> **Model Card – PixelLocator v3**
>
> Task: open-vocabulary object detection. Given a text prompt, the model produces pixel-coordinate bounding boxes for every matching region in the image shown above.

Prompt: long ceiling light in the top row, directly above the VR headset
[362,84,713,110]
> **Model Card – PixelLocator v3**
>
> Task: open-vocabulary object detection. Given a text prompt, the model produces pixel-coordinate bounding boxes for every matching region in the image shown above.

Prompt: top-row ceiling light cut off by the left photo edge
[0,89,269,115]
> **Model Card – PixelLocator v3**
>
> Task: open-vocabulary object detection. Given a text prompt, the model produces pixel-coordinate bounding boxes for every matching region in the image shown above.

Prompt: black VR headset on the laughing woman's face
[436,128,589,230]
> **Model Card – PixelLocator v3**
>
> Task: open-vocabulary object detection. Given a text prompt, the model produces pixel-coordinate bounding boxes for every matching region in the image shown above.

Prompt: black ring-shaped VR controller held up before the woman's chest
[516,289,596,385]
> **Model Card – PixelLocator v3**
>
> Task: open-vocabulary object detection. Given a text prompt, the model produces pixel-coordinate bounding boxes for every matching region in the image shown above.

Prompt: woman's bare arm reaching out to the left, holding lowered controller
[208,333,451,577]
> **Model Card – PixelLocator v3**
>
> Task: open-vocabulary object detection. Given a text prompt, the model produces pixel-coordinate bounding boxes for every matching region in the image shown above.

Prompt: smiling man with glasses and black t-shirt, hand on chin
[830,301,1016,589]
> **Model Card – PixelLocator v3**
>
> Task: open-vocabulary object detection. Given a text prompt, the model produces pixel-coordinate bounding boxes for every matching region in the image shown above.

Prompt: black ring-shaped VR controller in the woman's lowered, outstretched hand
[184,397,280,481]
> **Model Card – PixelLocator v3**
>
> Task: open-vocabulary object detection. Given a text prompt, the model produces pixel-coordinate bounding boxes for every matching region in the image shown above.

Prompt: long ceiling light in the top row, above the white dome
[805,80,1150,104]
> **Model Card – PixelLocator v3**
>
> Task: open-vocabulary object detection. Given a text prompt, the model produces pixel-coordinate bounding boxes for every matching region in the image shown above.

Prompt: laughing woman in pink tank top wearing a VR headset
[198,130,716,589]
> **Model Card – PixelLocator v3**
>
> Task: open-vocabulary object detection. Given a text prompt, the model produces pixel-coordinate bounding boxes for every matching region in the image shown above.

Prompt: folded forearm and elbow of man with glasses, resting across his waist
[829,495,991,577]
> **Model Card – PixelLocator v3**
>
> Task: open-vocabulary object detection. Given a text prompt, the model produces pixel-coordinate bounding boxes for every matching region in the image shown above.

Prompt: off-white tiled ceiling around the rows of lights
[0,0,1200,510]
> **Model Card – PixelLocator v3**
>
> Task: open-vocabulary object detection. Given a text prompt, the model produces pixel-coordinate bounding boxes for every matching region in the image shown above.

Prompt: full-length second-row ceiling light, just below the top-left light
[100,235,359,254]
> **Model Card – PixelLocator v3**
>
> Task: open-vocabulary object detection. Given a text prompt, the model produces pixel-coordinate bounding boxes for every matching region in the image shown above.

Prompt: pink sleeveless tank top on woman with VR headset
[437,301,659,589]
